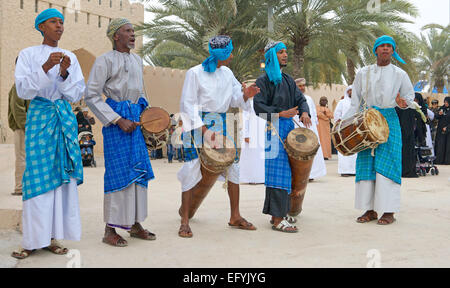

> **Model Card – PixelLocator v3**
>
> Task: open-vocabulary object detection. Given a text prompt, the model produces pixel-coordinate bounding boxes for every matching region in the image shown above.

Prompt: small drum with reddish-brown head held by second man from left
[140,107,171,150]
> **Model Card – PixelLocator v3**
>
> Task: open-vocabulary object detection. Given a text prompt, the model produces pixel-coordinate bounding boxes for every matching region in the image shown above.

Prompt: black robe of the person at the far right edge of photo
[434,106,450,165]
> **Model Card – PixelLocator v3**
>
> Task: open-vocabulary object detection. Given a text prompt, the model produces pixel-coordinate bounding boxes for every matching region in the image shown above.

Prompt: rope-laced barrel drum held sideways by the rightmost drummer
[331,109,389,156]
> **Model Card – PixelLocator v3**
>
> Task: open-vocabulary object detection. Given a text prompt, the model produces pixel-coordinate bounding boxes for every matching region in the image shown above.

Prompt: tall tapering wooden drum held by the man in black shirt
[285,128,320,217]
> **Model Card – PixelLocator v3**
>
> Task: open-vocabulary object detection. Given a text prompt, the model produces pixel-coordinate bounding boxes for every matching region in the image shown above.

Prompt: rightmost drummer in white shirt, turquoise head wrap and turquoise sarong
[343,35,414,225]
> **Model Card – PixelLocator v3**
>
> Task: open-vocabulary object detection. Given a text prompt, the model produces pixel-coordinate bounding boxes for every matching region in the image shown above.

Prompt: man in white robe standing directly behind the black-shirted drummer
[294,78,327,181]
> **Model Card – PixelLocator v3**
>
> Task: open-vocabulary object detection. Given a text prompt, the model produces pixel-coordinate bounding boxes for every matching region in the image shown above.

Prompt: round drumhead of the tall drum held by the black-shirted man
[286,128,319,156]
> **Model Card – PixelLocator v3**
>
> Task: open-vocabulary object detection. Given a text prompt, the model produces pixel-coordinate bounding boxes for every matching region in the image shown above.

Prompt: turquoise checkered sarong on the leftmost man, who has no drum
[22,97,83,201]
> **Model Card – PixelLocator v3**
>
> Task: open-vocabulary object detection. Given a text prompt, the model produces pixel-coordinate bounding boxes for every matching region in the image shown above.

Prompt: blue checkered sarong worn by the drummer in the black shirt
[265,118,295,194]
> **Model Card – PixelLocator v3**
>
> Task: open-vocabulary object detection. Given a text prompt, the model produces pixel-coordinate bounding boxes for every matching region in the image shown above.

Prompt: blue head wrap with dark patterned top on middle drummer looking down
[202,36,233,73]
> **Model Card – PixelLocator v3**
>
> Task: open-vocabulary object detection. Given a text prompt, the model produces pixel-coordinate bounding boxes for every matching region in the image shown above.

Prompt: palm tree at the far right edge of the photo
[418,24,450,93]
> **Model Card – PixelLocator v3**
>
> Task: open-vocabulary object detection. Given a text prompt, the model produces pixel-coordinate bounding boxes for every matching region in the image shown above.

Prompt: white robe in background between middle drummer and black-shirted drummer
[239,99,267,184]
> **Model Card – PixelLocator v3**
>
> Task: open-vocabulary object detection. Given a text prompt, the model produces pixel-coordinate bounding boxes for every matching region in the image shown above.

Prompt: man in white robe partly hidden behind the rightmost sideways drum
[334,86,358,177]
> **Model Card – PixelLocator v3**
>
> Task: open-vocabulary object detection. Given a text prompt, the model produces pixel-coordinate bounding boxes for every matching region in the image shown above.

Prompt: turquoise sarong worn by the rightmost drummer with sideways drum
[356,107,402,184]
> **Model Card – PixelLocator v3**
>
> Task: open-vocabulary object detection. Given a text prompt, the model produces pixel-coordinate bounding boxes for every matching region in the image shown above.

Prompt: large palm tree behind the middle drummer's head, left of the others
[137,0,267,80]
